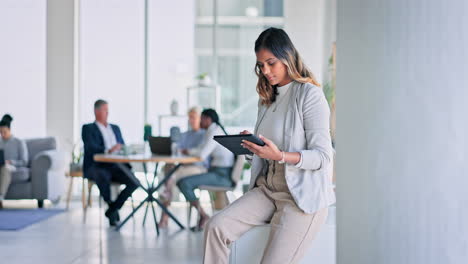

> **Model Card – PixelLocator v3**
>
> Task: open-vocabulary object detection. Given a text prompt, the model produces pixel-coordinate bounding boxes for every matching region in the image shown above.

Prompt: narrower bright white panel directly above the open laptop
[148,0,195,133]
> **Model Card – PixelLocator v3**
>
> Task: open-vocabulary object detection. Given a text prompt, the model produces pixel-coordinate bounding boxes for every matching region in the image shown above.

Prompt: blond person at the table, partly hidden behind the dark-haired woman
[159,107,208,228]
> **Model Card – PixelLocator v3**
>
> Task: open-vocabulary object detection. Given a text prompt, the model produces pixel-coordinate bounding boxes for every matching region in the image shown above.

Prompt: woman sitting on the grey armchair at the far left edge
[0,114,28,208]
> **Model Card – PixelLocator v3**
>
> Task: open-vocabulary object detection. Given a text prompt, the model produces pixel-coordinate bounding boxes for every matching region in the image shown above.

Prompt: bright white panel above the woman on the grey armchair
[0,0,46,138]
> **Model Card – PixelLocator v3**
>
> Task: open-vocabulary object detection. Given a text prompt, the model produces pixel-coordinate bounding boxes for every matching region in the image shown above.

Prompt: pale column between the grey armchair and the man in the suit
[47,0,78,151]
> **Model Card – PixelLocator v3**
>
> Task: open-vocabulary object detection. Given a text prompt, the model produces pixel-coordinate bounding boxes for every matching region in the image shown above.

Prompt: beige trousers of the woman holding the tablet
[203,162,328,264]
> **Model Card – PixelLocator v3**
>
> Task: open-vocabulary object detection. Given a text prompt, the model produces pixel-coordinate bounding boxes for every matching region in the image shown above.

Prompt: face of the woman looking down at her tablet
[256,49,291,86]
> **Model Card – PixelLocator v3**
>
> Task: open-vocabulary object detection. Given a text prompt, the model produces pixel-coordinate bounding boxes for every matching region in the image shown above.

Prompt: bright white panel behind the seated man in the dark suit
[80,0,144,143]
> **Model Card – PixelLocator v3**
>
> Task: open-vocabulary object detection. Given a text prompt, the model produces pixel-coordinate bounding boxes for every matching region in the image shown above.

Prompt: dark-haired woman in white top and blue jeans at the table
[177,109,234,231]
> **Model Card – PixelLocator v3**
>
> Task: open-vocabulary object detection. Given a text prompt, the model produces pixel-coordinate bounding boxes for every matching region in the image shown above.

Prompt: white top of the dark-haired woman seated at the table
[188,123,234,168]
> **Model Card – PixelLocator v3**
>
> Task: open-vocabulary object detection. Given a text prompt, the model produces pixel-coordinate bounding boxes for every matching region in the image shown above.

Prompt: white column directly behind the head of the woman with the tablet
[284,0,329,83]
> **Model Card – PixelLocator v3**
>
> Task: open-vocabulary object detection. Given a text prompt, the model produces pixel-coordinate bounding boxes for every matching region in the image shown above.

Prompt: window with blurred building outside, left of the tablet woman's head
[195,0,284,131]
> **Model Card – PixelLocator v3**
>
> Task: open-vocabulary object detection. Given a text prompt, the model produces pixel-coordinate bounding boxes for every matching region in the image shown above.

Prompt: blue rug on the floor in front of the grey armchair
[0,209,65,231]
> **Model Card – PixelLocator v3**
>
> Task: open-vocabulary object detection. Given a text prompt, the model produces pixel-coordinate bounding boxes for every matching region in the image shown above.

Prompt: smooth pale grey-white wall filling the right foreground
[337,0,468,264]
